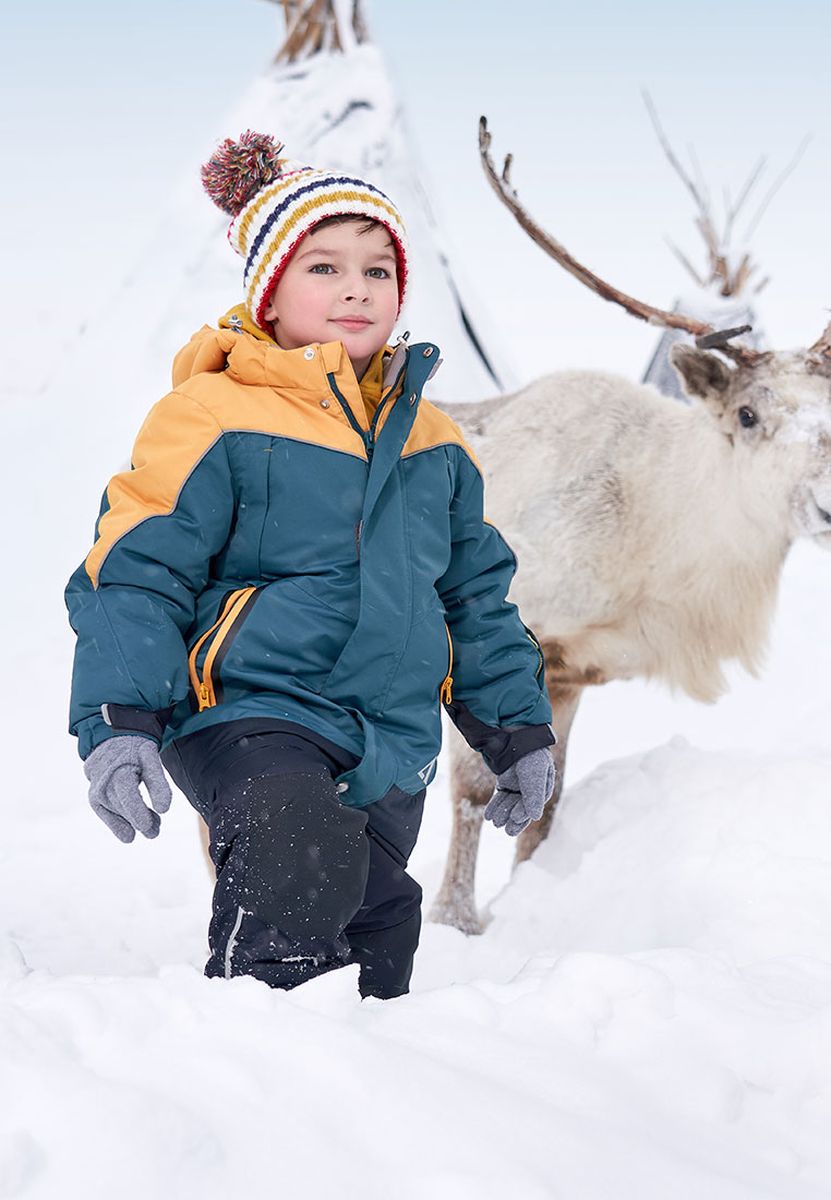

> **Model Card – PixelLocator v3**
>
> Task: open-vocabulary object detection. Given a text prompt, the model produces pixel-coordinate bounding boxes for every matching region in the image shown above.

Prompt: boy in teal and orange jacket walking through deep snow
[67,131,555,998]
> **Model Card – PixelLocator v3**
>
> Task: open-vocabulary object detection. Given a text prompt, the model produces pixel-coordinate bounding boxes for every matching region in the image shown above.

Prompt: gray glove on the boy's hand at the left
[84,734,173,841]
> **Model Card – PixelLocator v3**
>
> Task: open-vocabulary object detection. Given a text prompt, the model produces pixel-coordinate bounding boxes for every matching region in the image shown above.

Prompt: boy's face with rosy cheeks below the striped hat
[265,221,399,379]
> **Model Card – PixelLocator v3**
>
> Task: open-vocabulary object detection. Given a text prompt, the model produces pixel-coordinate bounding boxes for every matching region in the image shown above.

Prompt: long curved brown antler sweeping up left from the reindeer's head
[479,116,763,366]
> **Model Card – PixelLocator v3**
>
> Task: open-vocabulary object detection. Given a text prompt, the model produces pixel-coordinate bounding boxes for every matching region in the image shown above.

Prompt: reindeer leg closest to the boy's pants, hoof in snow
[428,734,494,934]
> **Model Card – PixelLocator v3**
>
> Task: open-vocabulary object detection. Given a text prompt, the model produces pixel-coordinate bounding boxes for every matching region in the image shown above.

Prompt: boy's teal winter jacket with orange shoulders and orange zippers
[66,318,554,805]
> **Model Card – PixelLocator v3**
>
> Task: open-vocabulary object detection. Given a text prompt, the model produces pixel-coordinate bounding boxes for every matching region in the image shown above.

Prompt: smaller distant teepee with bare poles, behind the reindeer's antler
[642,96,802,398]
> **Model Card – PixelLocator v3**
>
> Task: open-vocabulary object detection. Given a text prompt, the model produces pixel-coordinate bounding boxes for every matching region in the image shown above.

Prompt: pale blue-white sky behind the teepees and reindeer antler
[0,0,831,384]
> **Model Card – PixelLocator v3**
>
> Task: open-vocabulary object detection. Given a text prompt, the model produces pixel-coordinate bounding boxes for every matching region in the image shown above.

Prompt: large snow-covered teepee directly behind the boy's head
[104,0,515,401]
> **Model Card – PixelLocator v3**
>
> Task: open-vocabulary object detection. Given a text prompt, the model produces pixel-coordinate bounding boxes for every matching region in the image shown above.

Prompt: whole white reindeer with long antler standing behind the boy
[430,118,831,934]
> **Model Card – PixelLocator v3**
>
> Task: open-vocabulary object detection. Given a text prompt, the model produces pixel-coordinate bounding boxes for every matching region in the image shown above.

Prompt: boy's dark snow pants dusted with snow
[162,722,424,1000]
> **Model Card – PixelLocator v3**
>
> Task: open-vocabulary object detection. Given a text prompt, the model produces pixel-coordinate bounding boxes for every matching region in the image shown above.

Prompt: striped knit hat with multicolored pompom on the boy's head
[202,130,407,332]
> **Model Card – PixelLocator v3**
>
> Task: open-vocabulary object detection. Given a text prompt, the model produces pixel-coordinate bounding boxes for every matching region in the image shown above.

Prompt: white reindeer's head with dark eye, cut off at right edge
[670,338,831,548]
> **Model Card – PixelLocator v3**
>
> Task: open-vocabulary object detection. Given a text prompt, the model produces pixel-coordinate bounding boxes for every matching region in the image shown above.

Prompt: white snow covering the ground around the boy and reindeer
[0,16,831,1200]
